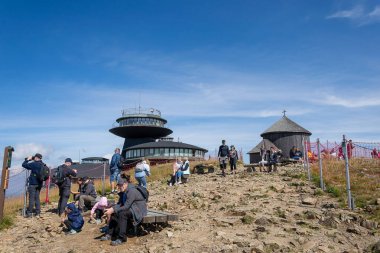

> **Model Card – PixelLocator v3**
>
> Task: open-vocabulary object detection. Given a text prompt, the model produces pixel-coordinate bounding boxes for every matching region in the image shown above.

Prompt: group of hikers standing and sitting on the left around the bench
[22,148,150,245]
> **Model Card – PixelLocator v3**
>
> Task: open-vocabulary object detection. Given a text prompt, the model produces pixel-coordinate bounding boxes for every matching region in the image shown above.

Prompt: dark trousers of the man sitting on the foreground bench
[109,210,133,240]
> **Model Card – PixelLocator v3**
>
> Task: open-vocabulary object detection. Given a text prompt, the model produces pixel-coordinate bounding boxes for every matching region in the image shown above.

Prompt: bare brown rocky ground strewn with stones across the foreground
[0,167,380,253]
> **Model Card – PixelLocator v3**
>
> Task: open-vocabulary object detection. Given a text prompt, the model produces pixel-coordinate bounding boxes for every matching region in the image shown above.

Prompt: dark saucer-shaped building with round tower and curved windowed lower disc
[109,108,207,164]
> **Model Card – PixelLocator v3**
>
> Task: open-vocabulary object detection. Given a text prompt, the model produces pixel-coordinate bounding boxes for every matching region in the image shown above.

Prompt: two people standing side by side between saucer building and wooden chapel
[218,140,239,177]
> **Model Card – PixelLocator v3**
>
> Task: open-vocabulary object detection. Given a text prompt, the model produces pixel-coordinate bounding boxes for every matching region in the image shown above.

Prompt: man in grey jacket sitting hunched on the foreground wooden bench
[101,178,148,246]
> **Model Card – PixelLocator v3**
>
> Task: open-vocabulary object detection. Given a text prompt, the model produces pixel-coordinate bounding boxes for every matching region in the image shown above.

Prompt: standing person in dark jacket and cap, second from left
[57,158,77,217]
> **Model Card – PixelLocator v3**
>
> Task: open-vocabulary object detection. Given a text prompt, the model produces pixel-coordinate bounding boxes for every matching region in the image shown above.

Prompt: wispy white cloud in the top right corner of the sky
[326,5,380,26]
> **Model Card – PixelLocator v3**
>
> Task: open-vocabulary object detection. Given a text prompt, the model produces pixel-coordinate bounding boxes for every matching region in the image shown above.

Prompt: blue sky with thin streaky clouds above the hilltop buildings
[0,0,380,174]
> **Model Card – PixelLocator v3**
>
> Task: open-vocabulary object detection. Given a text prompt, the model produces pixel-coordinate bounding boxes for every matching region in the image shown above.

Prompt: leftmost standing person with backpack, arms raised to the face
[22,153,43,218]
